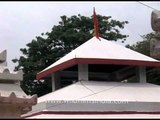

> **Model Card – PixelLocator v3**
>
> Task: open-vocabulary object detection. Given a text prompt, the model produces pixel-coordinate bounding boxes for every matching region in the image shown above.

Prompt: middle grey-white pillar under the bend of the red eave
[78,64,89,80]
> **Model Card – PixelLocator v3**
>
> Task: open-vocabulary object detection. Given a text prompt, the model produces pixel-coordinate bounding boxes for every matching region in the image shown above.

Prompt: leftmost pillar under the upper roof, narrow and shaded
[52,72,61,91]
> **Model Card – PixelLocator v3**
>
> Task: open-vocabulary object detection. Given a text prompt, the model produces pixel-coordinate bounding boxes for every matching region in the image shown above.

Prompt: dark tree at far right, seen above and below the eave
[126,32,160,85]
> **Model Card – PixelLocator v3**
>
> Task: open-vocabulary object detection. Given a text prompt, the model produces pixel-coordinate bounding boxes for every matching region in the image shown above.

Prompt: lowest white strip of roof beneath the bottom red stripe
[22,111,160,119]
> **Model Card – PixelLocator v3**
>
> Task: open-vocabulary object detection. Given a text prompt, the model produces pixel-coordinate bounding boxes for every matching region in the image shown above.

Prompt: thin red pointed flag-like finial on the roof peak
[93,8,99,39]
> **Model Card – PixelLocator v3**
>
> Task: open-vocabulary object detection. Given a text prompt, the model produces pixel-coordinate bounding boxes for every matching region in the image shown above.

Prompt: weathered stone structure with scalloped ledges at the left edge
[0,50,37,118]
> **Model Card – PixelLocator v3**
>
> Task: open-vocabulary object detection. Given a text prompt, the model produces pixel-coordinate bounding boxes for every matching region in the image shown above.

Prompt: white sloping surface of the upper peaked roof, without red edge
[41,37,159,72]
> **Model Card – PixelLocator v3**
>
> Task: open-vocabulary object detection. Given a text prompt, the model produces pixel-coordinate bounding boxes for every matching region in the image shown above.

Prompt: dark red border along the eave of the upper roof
[36,58,160,79]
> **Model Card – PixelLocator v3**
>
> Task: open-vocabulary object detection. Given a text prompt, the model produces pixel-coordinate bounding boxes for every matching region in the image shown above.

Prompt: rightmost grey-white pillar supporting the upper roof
[136,66,146,83]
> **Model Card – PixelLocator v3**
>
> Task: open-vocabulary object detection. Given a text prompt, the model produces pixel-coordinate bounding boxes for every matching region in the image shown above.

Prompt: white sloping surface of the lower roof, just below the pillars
[38,81,160,103]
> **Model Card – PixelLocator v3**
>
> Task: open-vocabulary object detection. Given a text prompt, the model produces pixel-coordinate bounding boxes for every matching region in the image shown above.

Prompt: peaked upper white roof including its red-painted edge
[37,37,160,79]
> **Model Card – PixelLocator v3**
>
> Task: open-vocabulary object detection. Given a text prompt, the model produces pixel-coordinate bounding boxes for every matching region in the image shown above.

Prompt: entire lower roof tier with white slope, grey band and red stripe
[23,81,160,118]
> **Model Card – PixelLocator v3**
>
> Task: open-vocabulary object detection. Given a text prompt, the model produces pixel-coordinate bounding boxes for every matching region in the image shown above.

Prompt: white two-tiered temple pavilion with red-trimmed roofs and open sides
[22,9,160,118]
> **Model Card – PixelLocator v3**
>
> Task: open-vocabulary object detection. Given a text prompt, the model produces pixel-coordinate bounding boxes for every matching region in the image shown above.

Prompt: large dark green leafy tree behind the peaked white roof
[13,14,128,96]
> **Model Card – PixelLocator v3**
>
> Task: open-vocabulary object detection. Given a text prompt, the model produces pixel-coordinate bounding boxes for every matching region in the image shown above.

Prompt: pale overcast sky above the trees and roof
[0,1,160,70]
